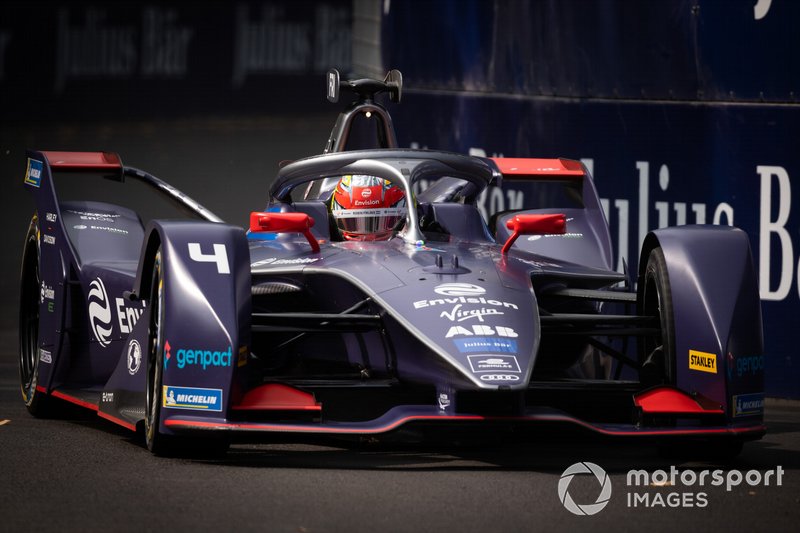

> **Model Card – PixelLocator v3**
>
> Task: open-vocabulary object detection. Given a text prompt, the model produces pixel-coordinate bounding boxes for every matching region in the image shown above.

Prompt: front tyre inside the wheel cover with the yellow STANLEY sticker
[638,248,675,388]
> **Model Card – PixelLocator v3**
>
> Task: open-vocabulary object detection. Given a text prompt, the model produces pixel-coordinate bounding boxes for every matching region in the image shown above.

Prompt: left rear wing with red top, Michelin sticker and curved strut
[23,150,222,222]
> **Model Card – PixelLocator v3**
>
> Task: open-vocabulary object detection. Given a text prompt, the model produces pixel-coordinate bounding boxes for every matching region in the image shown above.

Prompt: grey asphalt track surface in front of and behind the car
[0,117,800,533]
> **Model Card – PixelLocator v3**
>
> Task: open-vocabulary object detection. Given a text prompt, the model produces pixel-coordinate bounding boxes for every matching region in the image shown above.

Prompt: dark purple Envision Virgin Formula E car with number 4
[19,70,765,454]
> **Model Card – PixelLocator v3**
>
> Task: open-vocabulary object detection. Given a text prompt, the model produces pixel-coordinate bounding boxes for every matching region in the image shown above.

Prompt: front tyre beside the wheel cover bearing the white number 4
[144,248,229,457]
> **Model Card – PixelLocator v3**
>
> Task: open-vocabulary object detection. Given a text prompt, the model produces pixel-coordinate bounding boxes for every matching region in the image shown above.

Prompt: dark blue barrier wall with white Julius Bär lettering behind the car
[383,0,800,398]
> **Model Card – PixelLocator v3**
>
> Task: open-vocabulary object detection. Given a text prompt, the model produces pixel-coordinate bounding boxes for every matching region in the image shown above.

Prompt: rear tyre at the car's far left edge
[19,215,52,417]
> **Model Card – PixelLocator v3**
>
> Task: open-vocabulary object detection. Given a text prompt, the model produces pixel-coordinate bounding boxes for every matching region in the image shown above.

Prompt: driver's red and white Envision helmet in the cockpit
[331,174,406,241]
